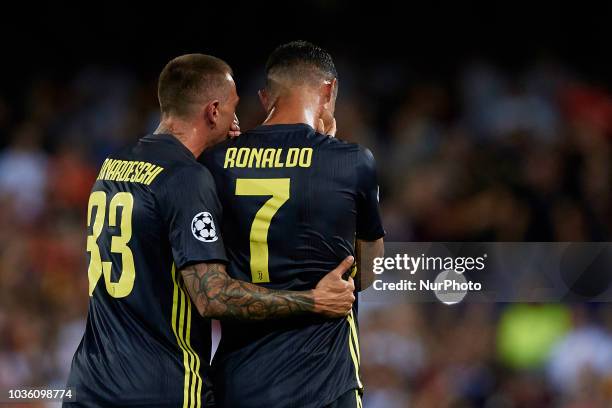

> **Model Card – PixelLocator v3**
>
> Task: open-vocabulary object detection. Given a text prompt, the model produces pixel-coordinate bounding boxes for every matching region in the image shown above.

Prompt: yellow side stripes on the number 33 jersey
[172,264,202,408]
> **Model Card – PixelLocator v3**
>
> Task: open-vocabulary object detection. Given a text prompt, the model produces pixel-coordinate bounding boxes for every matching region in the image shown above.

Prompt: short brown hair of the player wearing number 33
[157,54,232,117]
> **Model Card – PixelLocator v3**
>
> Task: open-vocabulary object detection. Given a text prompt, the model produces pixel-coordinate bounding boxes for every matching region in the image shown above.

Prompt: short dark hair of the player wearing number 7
[266,41,338,84]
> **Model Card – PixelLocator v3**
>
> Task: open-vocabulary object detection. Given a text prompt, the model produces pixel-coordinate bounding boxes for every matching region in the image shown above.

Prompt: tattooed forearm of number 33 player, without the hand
[181,263,315,320]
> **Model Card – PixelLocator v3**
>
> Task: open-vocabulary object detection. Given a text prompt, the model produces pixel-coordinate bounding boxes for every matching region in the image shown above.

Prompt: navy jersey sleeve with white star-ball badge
[160,165,227,269]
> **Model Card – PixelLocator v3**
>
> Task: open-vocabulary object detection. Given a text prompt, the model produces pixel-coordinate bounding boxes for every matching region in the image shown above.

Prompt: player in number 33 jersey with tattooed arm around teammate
[66,54,354,408]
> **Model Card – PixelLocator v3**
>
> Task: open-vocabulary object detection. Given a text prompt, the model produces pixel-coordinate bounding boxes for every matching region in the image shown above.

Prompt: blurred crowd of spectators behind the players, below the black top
[0,59,612,408]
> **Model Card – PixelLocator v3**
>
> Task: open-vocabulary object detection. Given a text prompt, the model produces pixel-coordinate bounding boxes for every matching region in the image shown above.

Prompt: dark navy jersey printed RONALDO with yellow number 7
[201,124,384,408]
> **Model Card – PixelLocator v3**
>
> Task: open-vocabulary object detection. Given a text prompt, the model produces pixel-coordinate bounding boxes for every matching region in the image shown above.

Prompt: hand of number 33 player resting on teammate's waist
[313,256,355,317]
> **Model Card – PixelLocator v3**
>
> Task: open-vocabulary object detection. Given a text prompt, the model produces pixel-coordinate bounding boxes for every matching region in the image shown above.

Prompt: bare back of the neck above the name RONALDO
[263,95,321,128]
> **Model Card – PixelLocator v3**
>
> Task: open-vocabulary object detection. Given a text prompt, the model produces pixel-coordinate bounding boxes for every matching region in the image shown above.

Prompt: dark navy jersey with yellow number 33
[68,135,227,408]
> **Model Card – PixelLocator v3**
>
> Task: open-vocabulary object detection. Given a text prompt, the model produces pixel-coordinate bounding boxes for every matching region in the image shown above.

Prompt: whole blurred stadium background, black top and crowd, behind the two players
[0,1,612,408]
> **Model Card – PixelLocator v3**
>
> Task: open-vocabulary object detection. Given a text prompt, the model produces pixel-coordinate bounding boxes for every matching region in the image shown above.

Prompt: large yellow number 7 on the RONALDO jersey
[236,178,291,283]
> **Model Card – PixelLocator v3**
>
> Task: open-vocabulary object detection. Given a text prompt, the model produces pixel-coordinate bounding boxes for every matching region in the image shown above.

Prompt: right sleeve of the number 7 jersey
[356,148,385,241]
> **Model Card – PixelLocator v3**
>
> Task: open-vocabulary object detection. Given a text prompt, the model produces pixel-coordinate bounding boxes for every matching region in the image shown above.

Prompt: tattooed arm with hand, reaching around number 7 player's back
[181,257,355,320]
